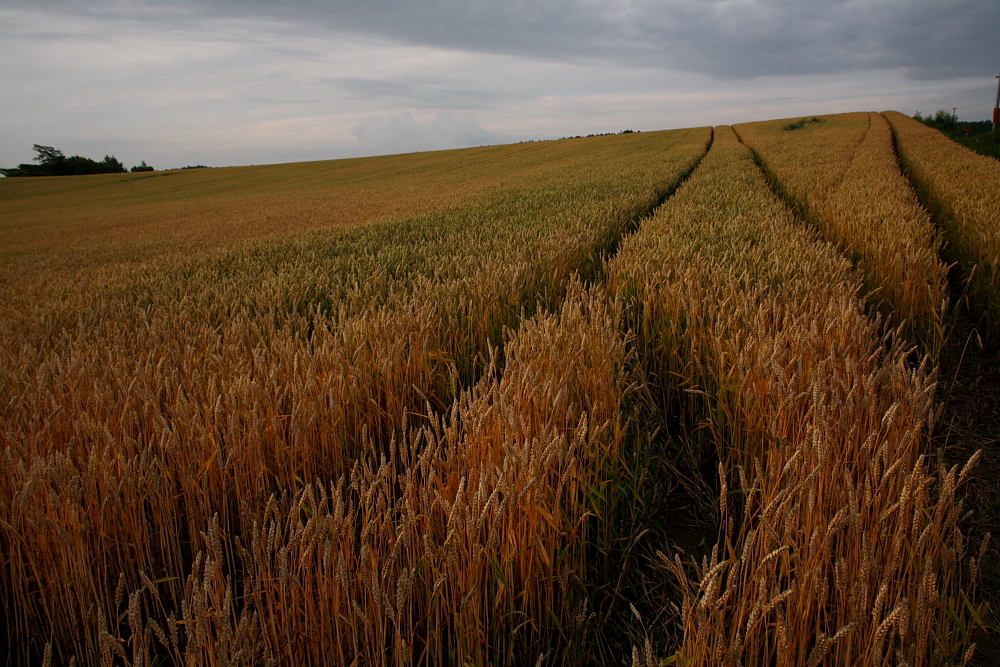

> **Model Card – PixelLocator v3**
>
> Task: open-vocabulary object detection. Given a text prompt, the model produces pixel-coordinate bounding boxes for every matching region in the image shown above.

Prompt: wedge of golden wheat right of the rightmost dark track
[883,111,1000,337]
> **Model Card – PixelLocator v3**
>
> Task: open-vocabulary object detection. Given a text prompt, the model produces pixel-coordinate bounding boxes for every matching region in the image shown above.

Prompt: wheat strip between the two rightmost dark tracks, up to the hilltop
[735,113,948,356]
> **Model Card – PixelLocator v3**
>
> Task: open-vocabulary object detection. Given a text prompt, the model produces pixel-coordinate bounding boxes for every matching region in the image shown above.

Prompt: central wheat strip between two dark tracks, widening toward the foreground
[609,127,968,666]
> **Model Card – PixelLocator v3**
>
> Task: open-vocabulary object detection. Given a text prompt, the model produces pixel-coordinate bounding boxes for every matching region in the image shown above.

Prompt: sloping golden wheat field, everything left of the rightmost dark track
[0,113,996,667]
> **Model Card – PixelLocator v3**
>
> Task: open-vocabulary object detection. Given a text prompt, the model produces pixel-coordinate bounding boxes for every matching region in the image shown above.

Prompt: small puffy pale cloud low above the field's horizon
[351,111,512,155]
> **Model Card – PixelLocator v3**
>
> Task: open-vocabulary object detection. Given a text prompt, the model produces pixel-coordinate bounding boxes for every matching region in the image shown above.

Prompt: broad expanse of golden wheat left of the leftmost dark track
[0,128,710,664]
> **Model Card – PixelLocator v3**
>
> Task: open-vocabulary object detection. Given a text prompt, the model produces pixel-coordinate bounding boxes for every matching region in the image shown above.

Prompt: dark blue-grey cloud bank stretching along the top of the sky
[11,0,1000,79]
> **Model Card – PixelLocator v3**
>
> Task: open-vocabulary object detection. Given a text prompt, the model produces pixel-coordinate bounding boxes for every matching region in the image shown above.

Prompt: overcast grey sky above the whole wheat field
[0,0,1000,168]
